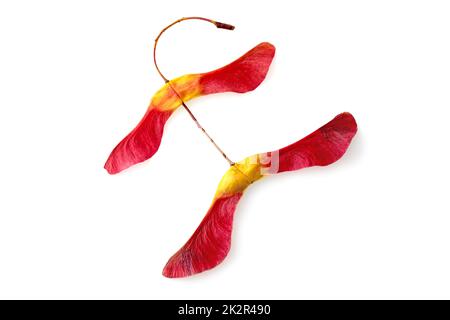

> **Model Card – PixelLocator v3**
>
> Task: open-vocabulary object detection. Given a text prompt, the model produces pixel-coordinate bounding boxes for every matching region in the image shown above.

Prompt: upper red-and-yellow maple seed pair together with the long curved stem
[104,17,275,174]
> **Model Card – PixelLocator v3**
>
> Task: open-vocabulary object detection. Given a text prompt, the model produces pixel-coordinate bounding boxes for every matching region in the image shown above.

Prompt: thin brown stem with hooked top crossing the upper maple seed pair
[153,17,234,166]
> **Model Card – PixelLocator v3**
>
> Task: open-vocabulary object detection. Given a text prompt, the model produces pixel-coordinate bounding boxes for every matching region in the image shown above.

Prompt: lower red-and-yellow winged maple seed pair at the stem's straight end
[163,112,357,278]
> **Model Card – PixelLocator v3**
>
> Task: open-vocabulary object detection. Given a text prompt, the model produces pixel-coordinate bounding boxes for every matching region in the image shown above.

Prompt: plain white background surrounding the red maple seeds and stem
[0,0,450,299]
